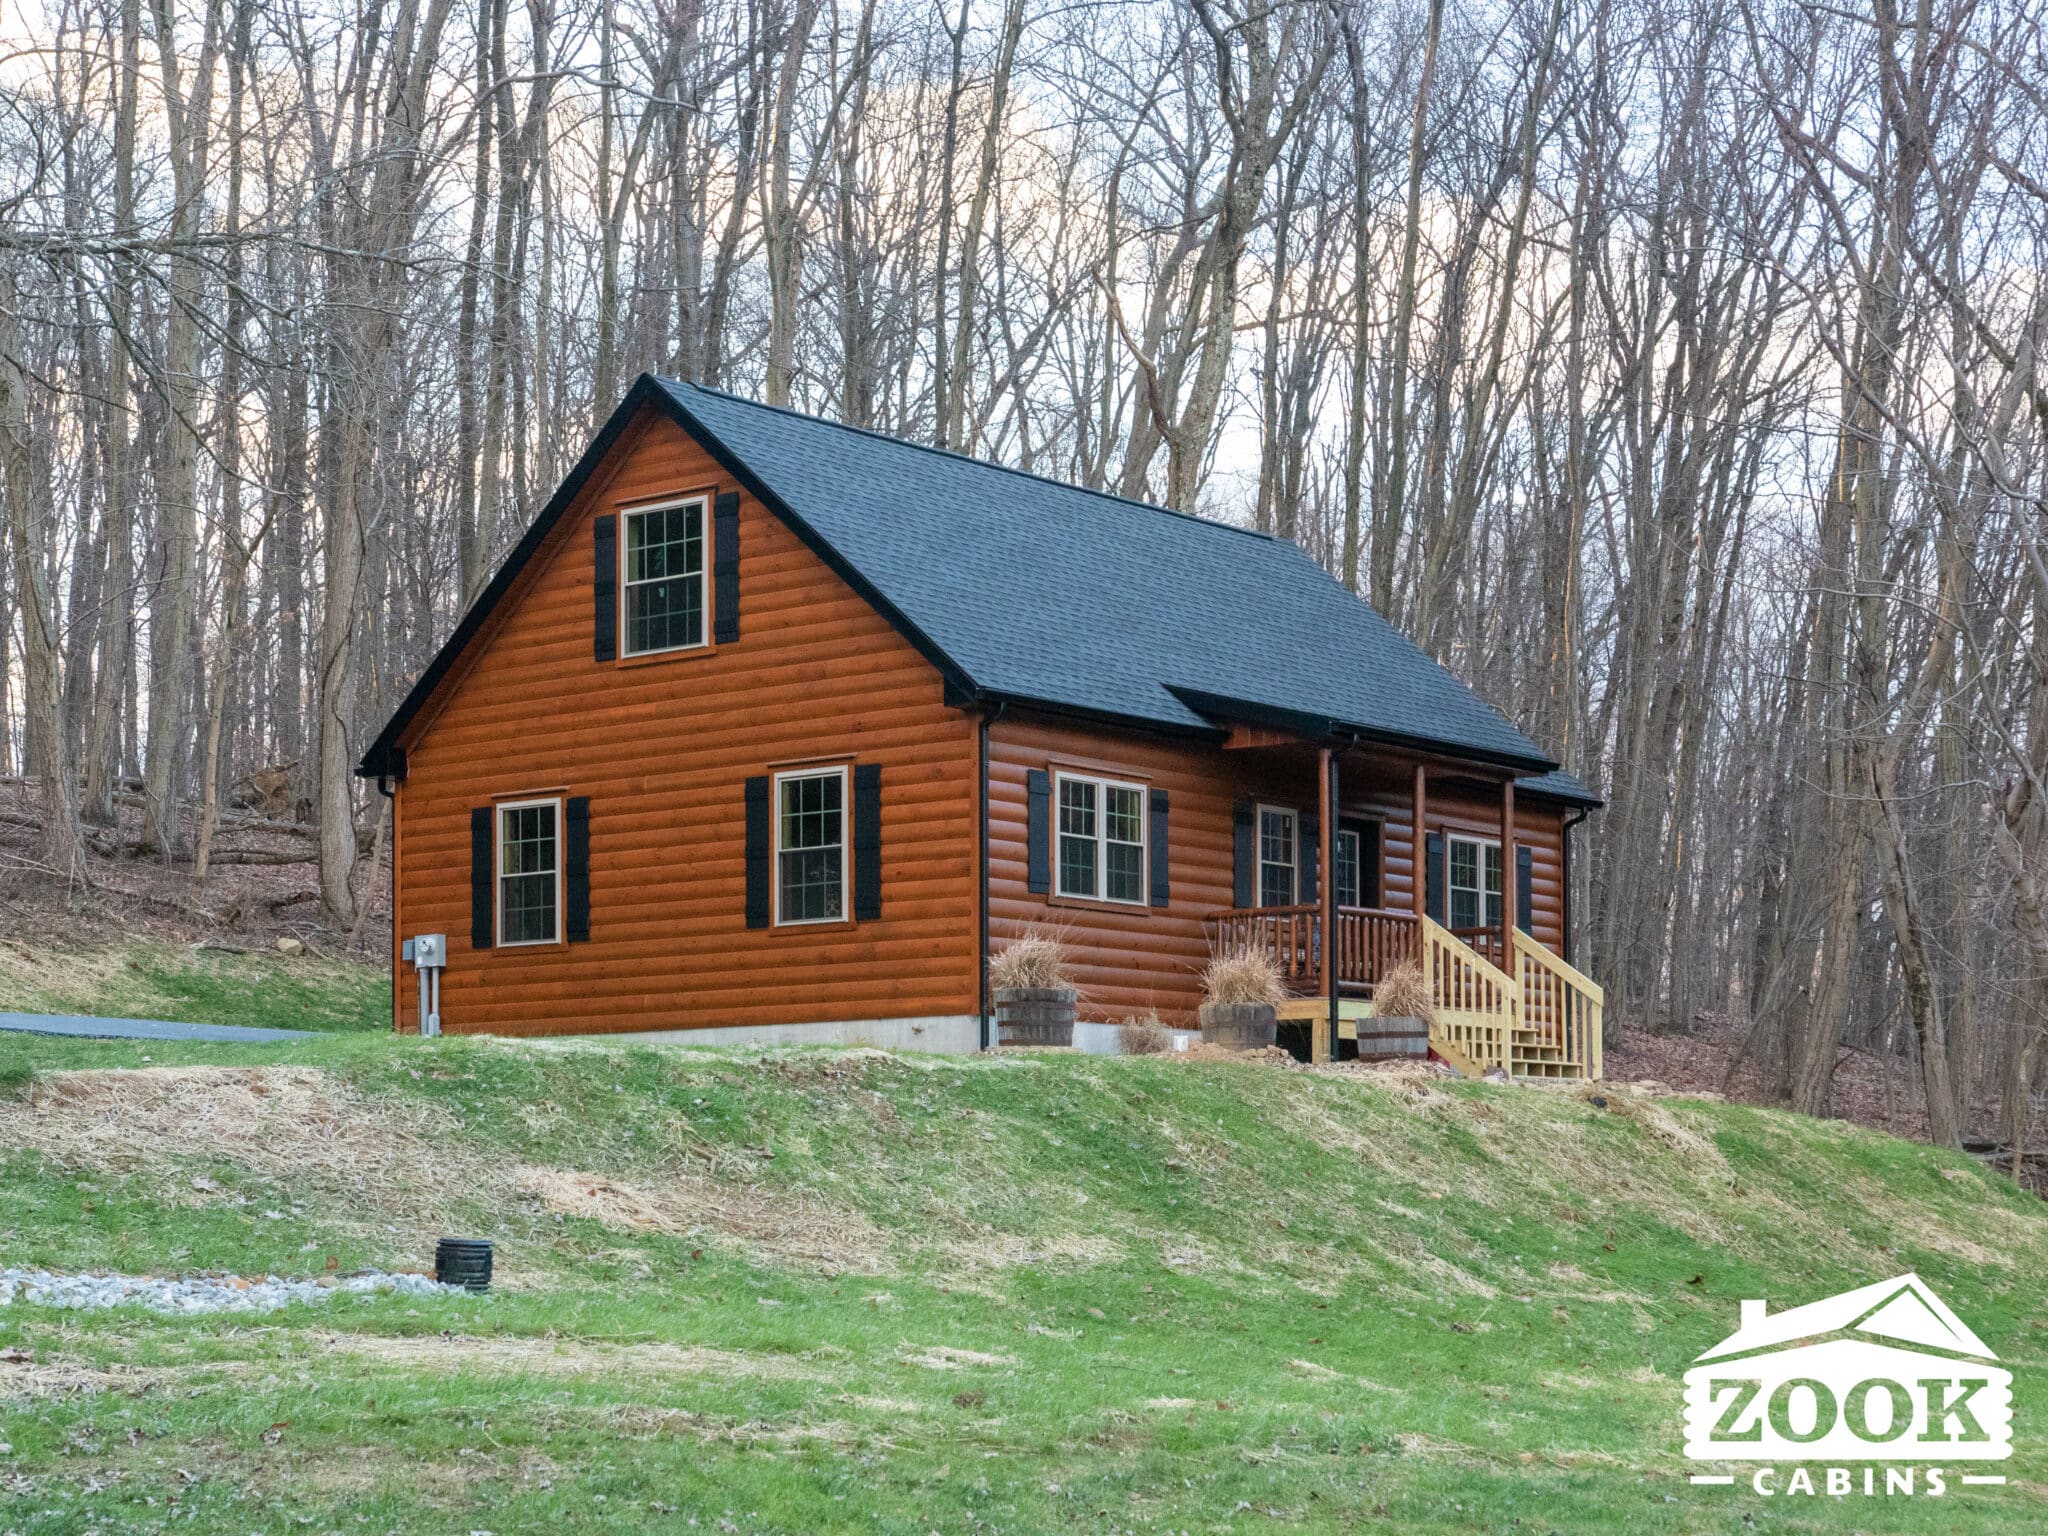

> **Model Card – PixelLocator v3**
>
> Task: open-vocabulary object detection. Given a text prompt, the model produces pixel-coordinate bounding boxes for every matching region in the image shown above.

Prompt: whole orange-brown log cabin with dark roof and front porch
[358,375,1599,1077]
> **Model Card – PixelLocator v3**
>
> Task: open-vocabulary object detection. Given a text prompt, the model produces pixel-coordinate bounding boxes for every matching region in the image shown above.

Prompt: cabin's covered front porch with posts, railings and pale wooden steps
[1204,725,1604,1077]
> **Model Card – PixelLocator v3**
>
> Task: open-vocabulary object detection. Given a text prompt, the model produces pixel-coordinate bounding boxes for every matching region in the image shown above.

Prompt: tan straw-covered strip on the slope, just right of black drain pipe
[512,1165,889,1274]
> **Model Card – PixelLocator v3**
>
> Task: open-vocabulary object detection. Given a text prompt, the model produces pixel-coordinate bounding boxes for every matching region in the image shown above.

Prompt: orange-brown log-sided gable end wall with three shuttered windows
[393,418,979,1034]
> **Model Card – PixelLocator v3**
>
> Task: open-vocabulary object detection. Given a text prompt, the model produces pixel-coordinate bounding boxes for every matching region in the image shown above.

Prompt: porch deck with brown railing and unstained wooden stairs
[1208,905,1606,1079]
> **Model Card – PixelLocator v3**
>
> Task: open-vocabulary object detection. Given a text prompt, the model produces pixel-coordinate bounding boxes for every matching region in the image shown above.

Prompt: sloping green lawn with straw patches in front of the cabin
[0,1036,2048,1536]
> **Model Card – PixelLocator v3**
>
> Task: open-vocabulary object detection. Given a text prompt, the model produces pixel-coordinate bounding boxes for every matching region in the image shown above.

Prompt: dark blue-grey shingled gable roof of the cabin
[365,377,1597,803]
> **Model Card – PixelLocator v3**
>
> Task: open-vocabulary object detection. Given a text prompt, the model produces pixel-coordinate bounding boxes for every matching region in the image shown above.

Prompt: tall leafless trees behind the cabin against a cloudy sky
[0,0,2048,1141]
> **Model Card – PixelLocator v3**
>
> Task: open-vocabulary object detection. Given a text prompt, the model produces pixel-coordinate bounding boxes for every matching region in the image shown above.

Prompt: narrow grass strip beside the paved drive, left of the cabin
[0,940,391,1032]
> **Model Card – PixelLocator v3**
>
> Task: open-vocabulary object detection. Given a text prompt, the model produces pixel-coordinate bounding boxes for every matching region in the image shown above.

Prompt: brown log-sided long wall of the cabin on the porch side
[989,715,1565,1026]
